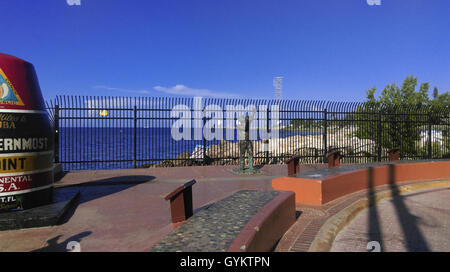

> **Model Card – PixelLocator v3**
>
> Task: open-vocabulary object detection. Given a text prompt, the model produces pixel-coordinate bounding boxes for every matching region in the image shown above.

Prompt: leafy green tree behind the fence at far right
[352,75,450,157]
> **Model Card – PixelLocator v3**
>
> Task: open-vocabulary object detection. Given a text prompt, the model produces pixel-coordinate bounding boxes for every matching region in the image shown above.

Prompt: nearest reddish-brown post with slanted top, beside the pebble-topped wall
[164,179,197,223]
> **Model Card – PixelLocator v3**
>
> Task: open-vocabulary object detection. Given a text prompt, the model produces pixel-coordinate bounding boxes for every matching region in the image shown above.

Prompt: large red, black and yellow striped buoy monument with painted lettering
[0,53,54,210]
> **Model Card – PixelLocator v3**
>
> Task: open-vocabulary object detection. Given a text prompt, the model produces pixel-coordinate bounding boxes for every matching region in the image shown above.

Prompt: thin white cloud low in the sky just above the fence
[93,84,241,98]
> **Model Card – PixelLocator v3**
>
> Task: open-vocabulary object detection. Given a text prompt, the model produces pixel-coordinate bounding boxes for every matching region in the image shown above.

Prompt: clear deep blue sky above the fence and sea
[0,0,450,101]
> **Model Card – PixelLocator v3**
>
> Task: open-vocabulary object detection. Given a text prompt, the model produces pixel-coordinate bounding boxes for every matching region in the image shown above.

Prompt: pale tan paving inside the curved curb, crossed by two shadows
[331,187,450,252]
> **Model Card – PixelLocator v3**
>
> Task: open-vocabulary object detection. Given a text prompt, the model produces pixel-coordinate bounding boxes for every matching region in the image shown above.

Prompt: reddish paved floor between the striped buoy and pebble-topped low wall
[0,165,298,251]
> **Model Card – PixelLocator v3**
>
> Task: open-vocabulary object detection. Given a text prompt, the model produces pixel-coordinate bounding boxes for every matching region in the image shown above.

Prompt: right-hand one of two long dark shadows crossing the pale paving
[389,164,430,252]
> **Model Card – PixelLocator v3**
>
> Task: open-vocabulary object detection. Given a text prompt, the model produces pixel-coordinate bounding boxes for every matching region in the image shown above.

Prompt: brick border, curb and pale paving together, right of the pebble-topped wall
[275,180,450,252]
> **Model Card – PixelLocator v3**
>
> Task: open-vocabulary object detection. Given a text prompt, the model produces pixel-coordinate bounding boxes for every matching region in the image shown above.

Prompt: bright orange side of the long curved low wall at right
[272,161,450,205]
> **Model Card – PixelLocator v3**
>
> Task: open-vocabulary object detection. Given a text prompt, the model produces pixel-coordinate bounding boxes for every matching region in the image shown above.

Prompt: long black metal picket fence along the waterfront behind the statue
[47,96,450,170]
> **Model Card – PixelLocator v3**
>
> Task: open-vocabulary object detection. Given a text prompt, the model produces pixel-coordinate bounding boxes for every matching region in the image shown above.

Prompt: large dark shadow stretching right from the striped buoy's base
[55,175,155,225]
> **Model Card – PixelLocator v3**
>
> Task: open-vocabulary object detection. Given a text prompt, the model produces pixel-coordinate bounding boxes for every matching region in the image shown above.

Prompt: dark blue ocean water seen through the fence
[59,127,321,170]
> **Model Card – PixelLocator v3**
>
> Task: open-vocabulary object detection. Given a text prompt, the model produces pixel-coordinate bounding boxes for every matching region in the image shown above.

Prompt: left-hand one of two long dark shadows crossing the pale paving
[367,167,384,251]
